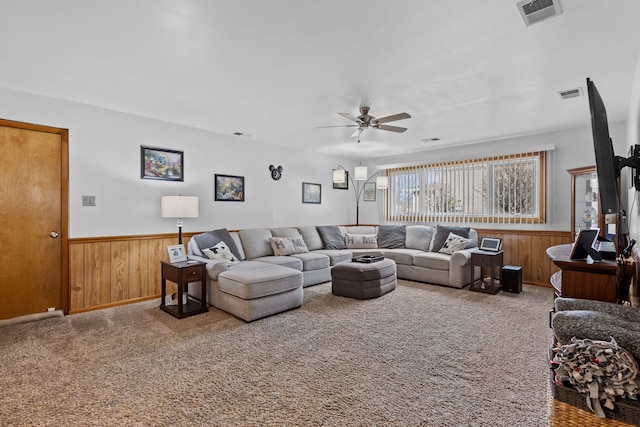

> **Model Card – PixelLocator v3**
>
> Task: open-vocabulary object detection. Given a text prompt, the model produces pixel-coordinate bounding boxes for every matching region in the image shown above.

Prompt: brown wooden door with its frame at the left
[0,120,68,319]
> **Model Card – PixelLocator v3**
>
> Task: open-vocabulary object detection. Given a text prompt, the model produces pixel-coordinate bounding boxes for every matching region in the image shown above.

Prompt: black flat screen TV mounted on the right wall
[587,78,620,215]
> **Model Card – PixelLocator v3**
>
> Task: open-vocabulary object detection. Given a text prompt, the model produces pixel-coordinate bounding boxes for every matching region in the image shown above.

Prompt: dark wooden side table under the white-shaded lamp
[160,261,208,319]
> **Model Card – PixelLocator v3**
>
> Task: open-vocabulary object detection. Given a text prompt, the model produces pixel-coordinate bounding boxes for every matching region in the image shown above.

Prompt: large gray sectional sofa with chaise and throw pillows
[187,225,478,322]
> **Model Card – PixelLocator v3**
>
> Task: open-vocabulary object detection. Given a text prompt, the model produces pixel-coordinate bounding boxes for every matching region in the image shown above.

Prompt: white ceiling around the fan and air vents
[0,0,640,159]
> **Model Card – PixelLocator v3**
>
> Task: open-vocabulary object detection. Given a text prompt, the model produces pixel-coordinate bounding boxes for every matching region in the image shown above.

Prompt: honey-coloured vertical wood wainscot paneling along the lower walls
[68,229,571,313]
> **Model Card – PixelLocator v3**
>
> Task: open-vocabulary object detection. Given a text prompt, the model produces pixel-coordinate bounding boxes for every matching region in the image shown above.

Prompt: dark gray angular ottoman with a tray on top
[331,258,397,299]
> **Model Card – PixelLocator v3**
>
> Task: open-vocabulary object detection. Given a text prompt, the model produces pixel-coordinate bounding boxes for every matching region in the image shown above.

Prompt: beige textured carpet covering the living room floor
[0,281,553,427]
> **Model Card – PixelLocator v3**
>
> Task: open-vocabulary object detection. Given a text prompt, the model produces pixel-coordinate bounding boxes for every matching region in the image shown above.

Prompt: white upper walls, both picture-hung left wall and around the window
[0,84,638,238]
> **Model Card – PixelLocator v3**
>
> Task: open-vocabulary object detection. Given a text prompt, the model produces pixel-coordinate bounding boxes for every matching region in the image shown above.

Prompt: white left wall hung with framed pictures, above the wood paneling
[0,88,355,238]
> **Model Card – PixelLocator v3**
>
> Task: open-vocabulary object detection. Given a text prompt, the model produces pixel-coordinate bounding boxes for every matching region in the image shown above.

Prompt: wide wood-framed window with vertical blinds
[387,152,546,224]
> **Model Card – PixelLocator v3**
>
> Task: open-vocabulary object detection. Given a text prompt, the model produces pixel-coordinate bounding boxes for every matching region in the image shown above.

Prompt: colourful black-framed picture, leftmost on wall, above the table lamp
[140,146,184,181]
